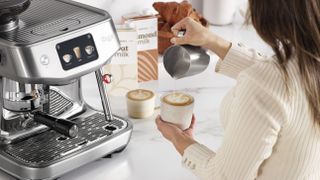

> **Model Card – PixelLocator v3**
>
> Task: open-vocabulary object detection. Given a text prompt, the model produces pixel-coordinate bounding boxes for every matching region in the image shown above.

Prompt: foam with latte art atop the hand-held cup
[162,92,194,106]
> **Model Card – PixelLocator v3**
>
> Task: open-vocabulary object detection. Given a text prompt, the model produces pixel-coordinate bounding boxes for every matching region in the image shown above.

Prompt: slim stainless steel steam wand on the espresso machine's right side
[95,69,113,121]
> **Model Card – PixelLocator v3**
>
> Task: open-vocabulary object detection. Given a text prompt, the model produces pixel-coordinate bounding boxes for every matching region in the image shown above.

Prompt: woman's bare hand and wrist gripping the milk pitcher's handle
[171,17,232,59]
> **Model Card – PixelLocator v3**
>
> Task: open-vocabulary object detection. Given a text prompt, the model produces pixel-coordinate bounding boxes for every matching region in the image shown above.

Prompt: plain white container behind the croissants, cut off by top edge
[203,0,237,25]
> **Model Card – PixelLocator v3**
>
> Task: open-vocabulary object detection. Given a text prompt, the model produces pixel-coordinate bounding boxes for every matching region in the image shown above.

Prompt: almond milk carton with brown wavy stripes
[123,13,158,82]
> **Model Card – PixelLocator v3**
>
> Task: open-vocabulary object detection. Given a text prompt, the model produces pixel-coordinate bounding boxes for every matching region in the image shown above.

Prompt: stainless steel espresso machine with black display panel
[0,0,132,179]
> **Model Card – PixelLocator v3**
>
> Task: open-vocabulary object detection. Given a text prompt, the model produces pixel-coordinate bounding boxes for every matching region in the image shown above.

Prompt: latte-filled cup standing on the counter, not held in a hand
[126,89,155,119]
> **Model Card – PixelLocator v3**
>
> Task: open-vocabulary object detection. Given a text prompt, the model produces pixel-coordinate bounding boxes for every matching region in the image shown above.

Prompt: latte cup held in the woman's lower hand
[160,92,194,130]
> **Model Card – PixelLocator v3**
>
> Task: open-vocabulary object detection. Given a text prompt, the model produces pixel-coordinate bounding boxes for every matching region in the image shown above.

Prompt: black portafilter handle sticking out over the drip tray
[34,112,79,138]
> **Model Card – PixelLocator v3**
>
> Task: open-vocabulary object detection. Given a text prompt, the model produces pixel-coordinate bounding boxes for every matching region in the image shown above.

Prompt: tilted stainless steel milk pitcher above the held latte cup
[163,45,210,79]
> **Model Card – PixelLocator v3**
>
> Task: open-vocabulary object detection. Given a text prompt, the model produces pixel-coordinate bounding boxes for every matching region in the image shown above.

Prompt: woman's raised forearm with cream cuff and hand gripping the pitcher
[171,18,267,79]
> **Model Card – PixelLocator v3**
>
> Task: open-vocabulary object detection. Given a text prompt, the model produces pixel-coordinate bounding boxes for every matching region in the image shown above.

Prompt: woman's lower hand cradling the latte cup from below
[156,116,197,155]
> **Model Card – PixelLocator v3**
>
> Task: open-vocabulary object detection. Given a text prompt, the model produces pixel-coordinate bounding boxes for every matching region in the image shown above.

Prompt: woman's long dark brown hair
[247,0,320,125]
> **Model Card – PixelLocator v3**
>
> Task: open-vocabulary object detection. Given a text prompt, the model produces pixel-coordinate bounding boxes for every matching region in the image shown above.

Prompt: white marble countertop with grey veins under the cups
[0,13,271,180]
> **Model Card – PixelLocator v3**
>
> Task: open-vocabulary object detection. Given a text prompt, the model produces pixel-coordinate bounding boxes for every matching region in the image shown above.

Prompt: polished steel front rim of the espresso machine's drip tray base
[0,111,132,179]
